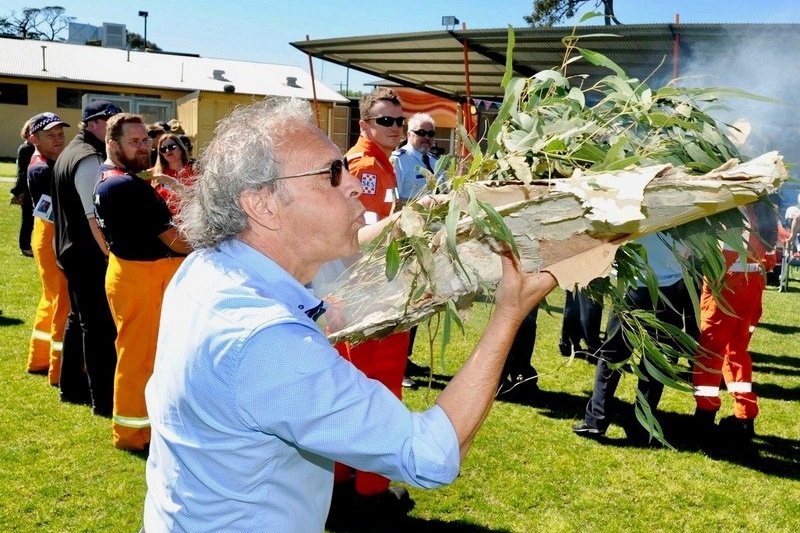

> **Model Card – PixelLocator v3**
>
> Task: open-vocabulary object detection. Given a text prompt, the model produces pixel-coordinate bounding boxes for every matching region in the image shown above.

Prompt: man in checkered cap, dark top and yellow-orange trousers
[28,113,69,386]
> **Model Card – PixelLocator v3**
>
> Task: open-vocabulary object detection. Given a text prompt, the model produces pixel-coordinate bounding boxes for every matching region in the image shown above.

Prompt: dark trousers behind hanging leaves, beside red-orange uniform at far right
[584,280,695,430]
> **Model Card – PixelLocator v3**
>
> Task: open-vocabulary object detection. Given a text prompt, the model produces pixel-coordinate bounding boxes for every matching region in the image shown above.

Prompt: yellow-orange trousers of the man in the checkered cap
[28,217,69,385]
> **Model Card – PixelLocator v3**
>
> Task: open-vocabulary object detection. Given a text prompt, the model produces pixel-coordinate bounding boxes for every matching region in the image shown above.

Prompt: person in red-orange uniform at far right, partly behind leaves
[692,200,778,443]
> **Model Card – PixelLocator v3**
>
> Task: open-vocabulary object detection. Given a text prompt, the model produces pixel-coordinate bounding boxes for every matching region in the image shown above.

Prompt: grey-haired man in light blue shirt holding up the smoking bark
[142,98,556,533]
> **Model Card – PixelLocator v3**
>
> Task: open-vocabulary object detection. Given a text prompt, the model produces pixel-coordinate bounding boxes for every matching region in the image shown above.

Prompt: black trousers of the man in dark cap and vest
[59,249,117,416]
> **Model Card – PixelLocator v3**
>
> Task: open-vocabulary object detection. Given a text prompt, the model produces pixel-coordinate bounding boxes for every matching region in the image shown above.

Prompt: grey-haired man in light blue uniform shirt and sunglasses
[392,113,444,202]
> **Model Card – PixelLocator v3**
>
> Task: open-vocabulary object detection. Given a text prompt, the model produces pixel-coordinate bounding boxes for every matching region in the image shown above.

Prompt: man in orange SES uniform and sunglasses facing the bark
[331,87,413,520]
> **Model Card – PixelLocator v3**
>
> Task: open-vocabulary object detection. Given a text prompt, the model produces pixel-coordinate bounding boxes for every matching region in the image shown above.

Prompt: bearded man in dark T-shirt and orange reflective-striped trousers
[94,113,191,450]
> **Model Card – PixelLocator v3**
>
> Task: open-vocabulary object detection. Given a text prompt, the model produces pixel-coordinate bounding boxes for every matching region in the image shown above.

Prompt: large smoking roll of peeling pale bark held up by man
[323,152,787,342]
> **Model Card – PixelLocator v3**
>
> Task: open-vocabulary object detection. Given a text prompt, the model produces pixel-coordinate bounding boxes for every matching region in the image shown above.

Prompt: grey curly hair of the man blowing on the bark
[178,98,314,249]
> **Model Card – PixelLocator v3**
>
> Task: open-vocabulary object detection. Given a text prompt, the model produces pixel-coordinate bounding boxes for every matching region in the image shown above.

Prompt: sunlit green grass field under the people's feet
[0,171,800,533]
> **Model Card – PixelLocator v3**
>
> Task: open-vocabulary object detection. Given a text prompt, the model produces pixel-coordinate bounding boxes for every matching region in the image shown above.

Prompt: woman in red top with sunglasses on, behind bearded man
[153,133,194,216]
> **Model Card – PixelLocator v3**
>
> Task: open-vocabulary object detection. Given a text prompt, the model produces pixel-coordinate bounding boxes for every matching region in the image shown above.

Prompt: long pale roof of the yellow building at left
[0,38,348,103]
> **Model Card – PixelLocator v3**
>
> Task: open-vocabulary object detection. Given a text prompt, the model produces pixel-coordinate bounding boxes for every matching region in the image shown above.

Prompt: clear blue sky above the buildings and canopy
[17,0,800,90]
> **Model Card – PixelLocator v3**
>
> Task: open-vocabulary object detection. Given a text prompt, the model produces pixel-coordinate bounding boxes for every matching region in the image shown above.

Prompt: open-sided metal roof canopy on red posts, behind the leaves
[291,24,800,100]
